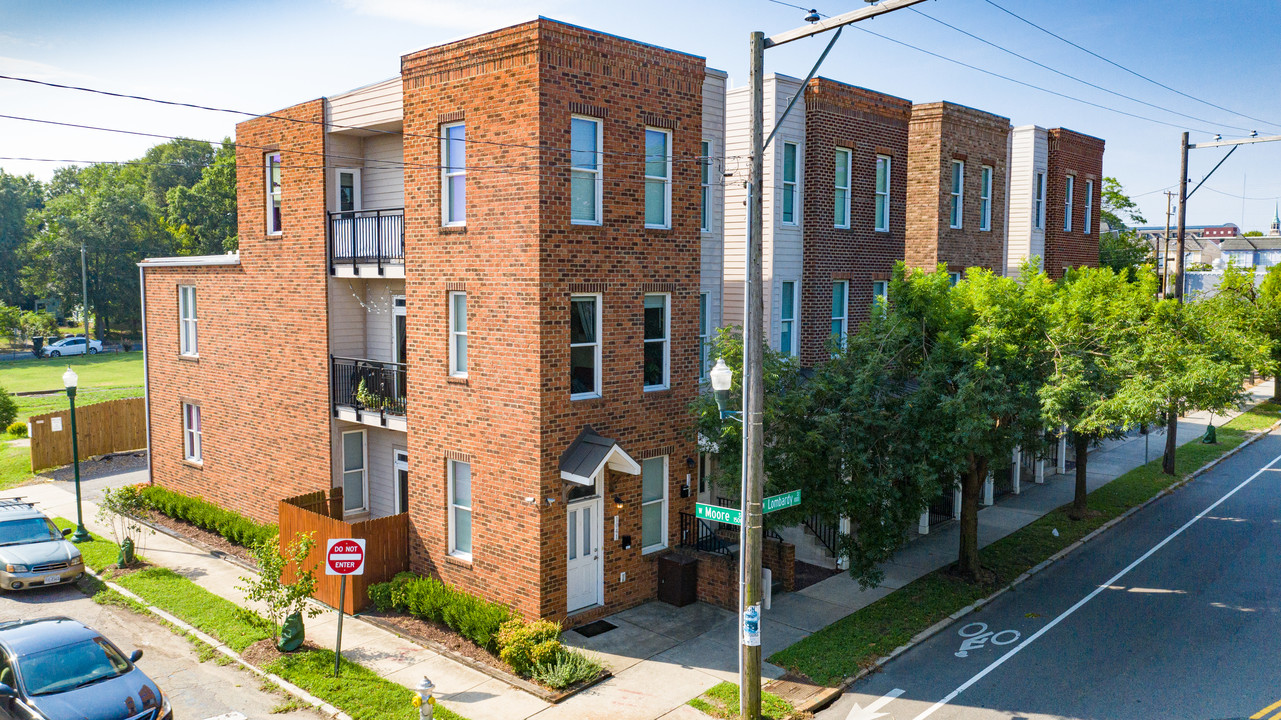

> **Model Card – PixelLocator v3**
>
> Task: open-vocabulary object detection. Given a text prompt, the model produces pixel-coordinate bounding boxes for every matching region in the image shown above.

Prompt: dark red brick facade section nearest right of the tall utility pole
[801,78,912,365]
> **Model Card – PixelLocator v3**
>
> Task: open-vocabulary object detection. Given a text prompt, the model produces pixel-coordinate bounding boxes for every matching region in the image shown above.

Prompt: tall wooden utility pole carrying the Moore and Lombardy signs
[738,0,925,720]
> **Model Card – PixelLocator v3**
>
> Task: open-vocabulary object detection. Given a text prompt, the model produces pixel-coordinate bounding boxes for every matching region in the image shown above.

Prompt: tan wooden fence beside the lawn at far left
[28,397,147,473]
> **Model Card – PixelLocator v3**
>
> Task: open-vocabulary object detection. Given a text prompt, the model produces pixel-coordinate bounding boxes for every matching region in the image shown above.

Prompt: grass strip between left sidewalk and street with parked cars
[54,518,465,720]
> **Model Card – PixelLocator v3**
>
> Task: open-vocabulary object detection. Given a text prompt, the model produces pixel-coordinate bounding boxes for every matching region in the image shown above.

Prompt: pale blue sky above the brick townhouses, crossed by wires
[0,0,1281,229]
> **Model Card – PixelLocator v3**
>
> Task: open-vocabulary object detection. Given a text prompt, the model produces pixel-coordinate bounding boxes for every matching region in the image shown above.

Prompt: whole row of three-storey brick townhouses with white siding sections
[141,18,1103,624]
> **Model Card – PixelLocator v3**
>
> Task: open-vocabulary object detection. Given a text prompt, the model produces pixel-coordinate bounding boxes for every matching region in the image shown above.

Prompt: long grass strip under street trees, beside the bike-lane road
[769,402,1281,685]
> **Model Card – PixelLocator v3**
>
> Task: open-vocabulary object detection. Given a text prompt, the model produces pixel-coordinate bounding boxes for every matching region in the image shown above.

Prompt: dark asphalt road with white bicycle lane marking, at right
[817,436,1281,720]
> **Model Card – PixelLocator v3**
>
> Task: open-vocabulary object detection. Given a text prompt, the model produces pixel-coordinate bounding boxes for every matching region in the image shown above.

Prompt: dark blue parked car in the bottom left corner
[0,609,173,720]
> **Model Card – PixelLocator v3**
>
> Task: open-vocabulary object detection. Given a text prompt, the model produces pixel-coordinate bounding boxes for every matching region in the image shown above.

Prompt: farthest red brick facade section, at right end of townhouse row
[1045,128,1104,278]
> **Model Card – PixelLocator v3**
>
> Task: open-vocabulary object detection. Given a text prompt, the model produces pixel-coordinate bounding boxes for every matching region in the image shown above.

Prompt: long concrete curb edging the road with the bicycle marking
[796,415,1281,712]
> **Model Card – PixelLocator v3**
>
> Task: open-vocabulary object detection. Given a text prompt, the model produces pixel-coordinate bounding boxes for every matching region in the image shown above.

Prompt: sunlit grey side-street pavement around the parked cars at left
[0,585,322,720]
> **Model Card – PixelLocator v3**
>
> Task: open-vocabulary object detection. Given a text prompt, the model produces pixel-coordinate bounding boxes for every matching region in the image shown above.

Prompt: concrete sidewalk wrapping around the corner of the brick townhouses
[0,382,1273,720]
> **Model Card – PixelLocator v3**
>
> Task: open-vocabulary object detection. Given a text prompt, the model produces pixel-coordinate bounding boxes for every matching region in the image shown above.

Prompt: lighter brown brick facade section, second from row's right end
[906,102,1009,272]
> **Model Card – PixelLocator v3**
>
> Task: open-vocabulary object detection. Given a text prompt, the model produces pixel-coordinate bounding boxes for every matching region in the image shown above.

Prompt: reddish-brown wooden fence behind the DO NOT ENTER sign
[279,488,409,612]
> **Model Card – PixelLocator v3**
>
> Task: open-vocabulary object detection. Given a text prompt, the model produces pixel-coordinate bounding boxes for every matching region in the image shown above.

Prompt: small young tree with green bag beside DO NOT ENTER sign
[237,533,320,652]
